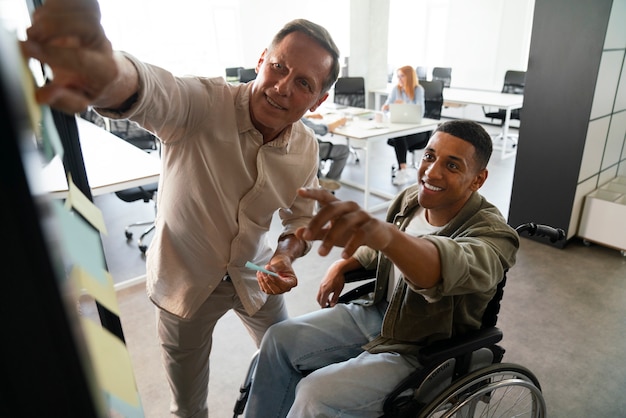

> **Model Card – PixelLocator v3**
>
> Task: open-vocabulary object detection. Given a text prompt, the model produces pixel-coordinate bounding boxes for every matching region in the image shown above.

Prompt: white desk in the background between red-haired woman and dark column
[443,88,524,159]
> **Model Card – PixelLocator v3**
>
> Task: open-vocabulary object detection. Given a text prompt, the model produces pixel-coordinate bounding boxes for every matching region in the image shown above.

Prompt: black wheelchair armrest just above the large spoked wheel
[418,327,502,365]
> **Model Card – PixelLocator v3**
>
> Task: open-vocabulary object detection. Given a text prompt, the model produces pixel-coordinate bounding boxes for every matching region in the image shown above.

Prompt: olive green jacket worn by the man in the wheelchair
[355,186,519,354]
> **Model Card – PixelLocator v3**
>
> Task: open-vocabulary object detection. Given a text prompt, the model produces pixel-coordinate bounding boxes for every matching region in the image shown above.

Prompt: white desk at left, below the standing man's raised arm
[36,117,161,198]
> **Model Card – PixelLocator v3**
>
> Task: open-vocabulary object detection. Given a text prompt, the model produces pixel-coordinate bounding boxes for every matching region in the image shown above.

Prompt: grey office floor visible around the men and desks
[95,127,626,418]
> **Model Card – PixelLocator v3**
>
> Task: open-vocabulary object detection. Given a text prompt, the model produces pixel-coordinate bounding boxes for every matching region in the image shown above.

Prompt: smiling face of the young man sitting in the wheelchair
[418,132,487,226]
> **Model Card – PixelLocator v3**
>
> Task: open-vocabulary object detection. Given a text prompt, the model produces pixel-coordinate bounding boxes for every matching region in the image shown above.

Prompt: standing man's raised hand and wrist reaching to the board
[22,0,138,113]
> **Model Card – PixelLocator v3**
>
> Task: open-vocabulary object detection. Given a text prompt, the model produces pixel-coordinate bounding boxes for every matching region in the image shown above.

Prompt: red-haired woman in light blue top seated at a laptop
[382,65,424,186]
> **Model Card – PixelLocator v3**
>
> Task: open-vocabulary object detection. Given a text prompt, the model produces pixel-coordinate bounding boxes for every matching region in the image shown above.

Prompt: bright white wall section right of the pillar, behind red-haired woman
[389,0,534,90]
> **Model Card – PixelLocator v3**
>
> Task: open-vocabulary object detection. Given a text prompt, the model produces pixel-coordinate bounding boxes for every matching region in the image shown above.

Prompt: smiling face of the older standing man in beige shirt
[250,32,332,142]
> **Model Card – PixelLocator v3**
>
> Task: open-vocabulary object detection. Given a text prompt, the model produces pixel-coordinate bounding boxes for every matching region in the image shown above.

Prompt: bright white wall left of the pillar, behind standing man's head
[99,0,350,76]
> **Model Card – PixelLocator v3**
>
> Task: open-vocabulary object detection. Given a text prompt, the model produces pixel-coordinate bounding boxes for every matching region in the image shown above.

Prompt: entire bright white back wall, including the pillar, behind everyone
[0,0,534,90]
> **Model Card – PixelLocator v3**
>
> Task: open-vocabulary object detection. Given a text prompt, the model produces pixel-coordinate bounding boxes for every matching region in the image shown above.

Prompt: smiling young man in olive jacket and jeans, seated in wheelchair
[245,120,519,418]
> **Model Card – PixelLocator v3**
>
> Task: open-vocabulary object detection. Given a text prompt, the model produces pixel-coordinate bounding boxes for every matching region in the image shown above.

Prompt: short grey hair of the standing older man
[268,19,340,93]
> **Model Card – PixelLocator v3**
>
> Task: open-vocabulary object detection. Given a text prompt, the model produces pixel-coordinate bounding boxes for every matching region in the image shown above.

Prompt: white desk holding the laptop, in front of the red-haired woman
[320,108,440,211]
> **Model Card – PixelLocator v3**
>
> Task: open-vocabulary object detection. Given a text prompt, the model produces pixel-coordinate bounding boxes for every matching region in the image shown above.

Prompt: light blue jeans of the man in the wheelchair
[245,304,419,418]
